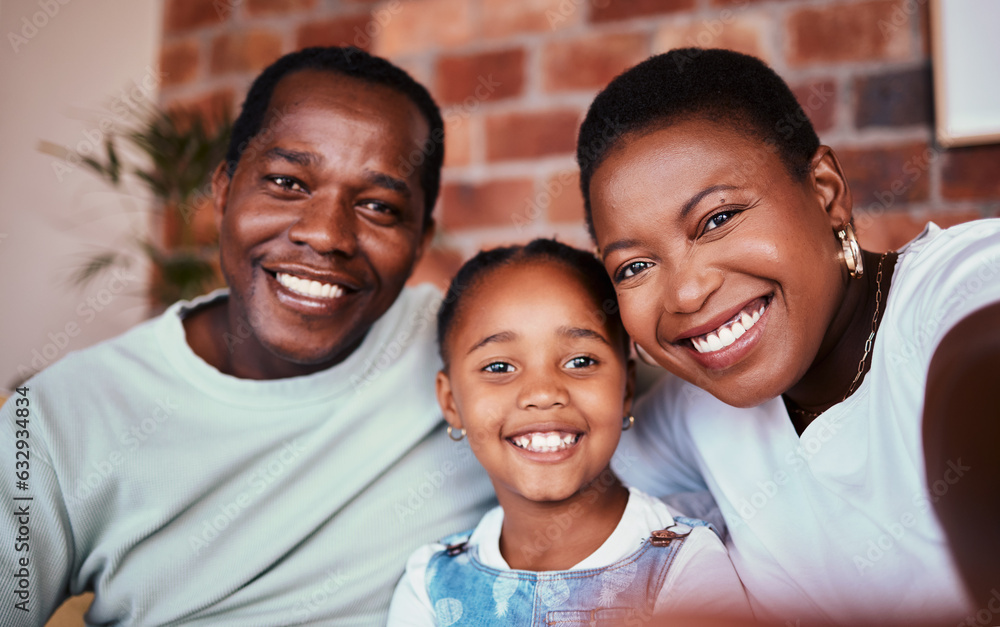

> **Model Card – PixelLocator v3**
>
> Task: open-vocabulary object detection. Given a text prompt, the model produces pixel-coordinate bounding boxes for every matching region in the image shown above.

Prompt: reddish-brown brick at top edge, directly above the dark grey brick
[787,0,912,66]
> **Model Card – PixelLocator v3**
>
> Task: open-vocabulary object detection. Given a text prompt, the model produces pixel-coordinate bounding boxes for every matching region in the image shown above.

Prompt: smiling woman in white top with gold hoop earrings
[577,49,1000,623]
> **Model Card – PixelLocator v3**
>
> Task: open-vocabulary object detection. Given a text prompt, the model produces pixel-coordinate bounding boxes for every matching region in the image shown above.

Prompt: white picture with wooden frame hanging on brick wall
[930,0,1000,148]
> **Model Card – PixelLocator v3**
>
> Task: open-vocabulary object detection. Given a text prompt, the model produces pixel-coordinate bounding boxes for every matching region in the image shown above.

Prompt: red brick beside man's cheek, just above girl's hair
[441,179,535,229]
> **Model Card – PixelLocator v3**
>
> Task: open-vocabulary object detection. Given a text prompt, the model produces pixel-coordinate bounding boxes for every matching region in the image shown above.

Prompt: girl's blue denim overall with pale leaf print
[425,516,711,627]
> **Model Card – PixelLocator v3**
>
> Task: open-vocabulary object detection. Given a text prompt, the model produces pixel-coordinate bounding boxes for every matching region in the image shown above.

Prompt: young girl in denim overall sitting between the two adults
[389,240,749,625]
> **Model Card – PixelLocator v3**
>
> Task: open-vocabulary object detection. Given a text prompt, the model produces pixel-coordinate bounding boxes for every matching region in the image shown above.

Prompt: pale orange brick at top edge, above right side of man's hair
[374,0,476,58]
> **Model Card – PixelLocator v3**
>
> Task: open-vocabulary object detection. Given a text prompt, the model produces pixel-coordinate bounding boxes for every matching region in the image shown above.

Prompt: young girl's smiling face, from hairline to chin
[438,260,631,509]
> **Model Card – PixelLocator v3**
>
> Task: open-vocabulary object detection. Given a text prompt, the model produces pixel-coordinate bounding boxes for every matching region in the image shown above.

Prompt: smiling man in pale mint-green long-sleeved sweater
[0,48,493,626]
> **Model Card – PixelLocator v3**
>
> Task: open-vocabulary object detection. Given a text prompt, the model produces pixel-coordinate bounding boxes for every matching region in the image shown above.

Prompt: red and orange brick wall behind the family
[161,0,1000,288]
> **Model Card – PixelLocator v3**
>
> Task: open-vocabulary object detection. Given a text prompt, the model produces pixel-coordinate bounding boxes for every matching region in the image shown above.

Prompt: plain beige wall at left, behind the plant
[0,0,162,392]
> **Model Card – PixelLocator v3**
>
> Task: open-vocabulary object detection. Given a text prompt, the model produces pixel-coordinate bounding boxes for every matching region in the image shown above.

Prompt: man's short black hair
[226,46,444,228]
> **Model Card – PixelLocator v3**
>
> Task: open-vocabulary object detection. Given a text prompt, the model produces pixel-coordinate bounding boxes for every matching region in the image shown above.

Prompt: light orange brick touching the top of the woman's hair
[653,9,770,61]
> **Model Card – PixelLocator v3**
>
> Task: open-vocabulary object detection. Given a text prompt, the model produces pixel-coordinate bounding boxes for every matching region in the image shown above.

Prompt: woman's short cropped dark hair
[576,48,819,236]
